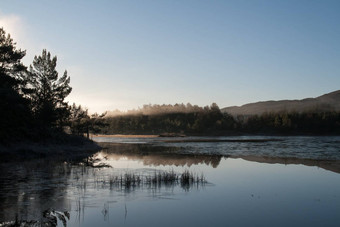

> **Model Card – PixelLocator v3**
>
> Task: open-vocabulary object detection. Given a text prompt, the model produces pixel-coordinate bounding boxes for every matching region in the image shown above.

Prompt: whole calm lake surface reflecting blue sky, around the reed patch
[0,137,340,226]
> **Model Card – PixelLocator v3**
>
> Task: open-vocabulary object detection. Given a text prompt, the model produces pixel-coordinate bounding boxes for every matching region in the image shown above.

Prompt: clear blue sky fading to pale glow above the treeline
[0,0,340,113]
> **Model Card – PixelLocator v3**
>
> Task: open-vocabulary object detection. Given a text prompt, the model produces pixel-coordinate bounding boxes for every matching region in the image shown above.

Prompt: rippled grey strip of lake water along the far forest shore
[96,136,340,161]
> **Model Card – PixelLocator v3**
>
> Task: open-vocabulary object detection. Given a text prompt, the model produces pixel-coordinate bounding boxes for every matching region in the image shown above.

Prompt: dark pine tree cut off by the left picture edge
[0,28,31,143]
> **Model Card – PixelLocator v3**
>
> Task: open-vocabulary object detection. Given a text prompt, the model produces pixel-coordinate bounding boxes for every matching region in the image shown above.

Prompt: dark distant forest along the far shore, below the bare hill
[76,103,340,135]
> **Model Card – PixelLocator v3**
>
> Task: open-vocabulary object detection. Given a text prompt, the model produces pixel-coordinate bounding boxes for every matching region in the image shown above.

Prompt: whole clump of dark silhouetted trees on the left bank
[0,28,95,148]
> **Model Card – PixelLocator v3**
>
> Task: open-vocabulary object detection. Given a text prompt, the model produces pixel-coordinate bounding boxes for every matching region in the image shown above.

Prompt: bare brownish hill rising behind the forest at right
[221,90,340,116]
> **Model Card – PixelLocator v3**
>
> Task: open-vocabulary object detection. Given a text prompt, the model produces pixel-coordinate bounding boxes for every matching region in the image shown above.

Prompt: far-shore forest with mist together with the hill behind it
[83,91,340,135]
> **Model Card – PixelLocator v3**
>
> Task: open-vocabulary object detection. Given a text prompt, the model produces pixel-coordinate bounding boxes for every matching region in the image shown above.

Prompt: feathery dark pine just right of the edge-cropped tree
[30,49,72,128]
